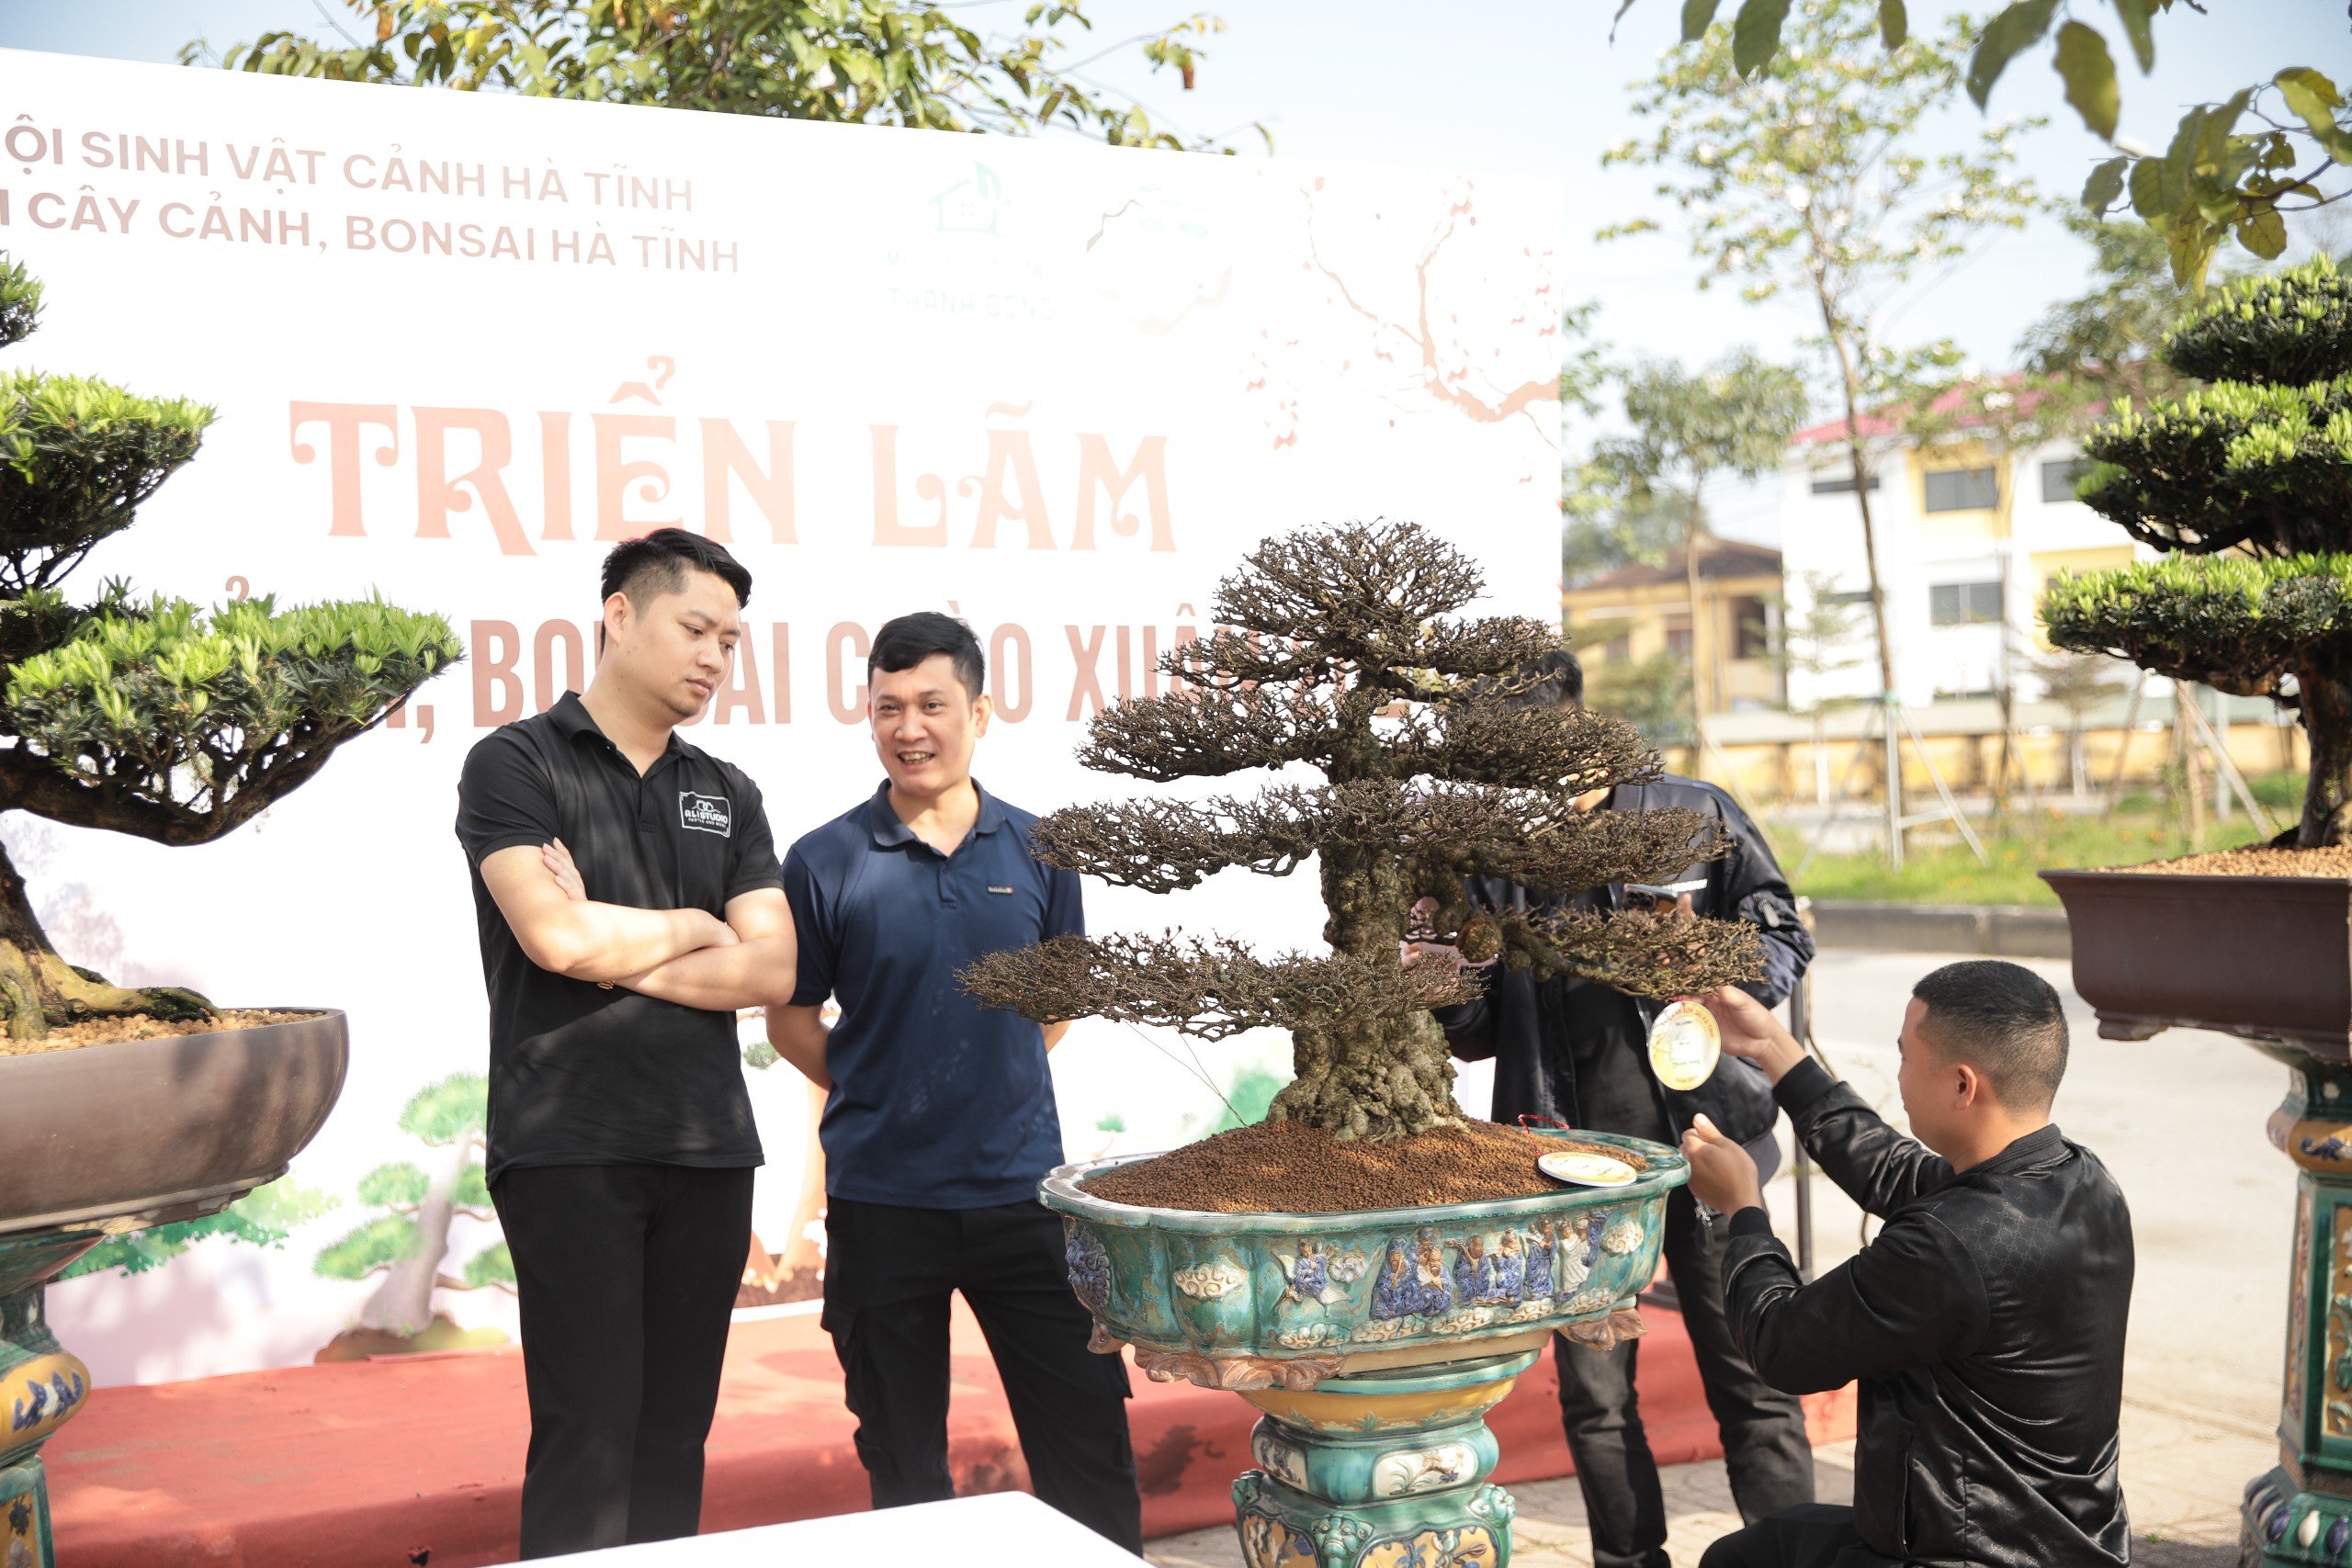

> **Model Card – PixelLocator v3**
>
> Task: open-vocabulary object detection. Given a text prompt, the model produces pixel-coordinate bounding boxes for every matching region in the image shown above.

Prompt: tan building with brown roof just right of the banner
[1559,538,1782,712]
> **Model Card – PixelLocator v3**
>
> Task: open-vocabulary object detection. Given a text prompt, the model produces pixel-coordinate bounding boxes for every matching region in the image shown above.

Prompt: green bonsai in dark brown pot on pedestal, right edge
[2041,256,2352,1563]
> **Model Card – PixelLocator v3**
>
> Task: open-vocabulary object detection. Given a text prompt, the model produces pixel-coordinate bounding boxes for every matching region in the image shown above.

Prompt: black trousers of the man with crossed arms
[489,1164,752,1556]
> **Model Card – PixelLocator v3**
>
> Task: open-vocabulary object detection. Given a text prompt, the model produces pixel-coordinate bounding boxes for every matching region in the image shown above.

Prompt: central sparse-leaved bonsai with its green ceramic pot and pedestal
[967,525,1755,1568]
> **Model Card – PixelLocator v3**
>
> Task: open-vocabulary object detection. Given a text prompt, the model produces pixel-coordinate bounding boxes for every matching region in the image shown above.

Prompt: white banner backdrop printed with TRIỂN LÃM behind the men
[0,51,1562,1382]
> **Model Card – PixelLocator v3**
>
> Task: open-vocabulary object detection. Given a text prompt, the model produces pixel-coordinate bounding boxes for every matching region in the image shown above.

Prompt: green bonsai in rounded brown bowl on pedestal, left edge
[0,256,458,1568]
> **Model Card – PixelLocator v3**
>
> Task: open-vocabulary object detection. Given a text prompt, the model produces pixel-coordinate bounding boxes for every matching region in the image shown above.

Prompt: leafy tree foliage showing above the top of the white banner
[195,0,1272,148]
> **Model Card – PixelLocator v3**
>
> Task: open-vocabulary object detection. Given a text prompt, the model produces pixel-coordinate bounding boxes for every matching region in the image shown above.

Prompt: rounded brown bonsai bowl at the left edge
[0,1009,350,1235]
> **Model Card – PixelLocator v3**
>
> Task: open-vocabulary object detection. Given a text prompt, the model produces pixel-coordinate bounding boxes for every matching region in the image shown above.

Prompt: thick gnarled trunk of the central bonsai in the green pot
[1265,846,1463,1140]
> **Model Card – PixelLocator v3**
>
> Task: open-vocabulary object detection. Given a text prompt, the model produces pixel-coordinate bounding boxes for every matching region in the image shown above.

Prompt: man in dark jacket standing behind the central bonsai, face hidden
[1437,651,1814,1568]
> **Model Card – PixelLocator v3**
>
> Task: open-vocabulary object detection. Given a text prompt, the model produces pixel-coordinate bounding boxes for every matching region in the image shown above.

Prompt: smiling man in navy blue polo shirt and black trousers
[767,611,1143,1551]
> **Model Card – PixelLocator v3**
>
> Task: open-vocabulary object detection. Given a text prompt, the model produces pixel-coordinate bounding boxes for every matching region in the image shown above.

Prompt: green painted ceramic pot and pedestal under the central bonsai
[1040,1134,1689,1568]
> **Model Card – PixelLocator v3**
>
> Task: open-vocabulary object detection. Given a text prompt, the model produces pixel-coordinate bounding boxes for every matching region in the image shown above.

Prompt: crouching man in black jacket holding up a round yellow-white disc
[1684,959,2131,1568]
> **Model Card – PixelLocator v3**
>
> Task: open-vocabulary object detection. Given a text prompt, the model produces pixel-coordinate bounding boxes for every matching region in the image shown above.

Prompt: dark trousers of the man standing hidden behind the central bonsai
[1553,1187,1814,1568]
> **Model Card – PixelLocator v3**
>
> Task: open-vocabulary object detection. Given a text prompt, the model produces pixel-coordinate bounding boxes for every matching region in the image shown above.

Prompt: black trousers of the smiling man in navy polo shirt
[826,1199,1143,1554]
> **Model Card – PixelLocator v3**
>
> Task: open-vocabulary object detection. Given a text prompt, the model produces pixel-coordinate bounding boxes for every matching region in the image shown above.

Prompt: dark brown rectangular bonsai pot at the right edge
[2041,870,2352,1060]
